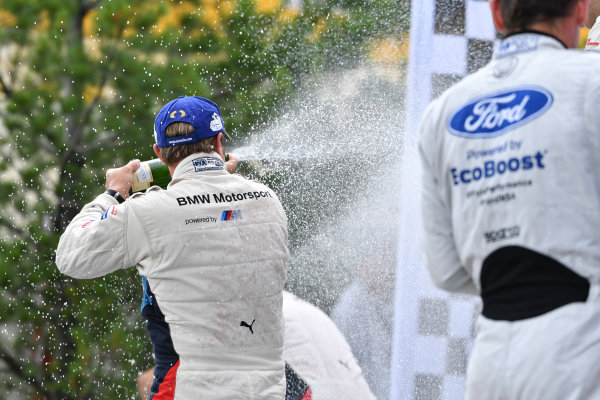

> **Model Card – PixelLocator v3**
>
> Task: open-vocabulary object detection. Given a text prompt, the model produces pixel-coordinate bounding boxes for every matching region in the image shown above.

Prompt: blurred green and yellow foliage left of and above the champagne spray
[0,0,406,399]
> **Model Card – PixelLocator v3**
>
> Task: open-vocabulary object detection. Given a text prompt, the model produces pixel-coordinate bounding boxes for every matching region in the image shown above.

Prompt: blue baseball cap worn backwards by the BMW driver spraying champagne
[154,96,231,147]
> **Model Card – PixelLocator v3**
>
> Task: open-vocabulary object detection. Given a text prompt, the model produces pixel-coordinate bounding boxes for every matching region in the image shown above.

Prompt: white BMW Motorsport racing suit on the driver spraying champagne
[56,154,289,400]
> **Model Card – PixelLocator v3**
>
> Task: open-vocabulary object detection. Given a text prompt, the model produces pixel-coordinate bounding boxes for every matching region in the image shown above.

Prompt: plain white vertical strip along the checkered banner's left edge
[390,0,435,400]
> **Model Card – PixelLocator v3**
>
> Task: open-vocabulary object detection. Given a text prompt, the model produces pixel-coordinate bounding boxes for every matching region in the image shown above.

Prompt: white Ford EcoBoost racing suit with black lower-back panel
[420,33,600,400]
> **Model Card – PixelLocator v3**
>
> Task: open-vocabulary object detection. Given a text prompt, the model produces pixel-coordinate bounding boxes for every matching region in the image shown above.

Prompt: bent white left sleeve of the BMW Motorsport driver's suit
[56,194,149,279]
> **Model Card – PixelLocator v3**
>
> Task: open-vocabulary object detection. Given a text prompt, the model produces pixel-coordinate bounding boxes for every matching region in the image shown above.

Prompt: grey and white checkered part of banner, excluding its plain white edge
[413,0,495,400]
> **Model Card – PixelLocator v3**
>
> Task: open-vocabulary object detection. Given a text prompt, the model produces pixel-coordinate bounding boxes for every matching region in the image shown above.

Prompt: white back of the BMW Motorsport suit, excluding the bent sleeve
[134,154,288,399]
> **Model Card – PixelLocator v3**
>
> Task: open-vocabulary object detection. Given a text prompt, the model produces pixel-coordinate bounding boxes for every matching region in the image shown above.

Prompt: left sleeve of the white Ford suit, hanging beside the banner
[419,106,478,295]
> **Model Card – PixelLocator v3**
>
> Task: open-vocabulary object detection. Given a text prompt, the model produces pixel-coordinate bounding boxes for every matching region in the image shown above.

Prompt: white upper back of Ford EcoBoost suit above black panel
[421,33,600,289]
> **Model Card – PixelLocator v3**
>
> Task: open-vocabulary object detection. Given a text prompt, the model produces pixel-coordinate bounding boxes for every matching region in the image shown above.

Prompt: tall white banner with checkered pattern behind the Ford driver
[390,0,496,400]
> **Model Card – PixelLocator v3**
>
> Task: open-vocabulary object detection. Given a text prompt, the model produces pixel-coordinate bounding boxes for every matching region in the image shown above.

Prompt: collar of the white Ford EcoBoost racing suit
[494,30,567,59]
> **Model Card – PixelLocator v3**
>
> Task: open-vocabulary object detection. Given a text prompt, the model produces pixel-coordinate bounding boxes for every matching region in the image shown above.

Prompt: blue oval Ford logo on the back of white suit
[448,86,554,139]
